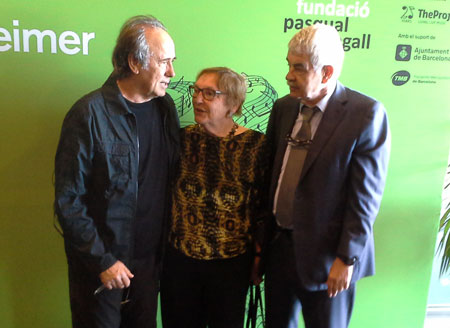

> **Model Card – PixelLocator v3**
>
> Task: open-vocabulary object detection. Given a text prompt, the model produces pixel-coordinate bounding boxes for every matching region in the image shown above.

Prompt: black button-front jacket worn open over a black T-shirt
[55,75,179,274]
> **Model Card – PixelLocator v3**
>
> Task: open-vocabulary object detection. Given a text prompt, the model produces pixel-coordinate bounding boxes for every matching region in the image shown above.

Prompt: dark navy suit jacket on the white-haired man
[267,82,390,291]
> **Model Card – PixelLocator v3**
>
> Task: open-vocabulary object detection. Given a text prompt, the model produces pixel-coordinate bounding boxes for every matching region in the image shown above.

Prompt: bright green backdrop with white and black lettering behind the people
[0,0,450,328]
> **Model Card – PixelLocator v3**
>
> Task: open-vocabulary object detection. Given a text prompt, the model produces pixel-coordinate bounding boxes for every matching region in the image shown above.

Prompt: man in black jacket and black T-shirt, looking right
[55,16,179,328]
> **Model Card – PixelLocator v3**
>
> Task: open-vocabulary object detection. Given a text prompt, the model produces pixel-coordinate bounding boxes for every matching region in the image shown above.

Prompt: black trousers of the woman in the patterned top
[161,247,251,328]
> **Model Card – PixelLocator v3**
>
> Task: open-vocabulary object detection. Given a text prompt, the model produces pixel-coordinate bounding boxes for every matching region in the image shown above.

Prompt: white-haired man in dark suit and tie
[265,24,390,328]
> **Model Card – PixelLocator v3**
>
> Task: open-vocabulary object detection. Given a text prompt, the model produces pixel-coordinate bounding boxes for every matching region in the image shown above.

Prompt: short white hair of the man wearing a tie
[289,24,344,79]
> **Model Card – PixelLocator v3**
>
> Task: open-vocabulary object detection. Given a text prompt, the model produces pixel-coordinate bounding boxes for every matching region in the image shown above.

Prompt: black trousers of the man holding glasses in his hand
[69,259,159,328]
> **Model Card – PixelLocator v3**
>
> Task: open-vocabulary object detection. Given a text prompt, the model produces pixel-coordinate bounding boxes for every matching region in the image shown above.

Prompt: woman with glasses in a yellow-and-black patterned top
[161,67,268,328]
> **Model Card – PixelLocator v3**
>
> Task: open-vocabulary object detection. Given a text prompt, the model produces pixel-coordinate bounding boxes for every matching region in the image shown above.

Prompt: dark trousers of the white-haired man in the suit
[265,232,356,328]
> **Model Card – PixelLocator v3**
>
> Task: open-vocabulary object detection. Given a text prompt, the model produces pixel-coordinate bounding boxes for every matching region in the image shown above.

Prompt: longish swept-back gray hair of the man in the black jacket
[112,15,167,79]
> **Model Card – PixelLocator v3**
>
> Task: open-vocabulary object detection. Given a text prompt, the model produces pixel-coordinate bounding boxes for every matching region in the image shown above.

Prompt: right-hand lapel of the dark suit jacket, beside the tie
[299,81,347,182]
